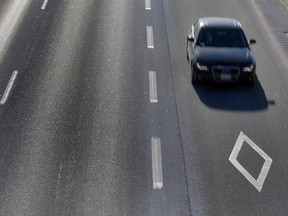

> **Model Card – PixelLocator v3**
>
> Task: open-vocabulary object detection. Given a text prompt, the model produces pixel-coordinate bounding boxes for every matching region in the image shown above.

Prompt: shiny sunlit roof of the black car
[199,17,241,28]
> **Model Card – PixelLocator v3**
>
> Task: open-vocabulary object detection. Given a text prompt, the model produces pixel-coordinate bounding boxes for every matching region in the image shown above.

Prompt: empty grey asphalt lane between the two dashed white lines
[1,1,150,215]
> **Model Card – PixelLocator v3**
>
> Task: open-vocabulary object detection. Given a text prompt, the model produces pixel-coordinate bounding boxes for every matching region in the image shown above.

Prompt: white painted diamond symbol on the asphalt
[229,131,272,192]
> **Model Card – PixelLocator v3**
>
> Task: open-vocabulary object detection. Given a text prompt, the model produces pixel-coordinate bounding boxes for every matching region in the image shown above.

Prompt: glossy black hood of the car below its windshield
[194,46,254,66]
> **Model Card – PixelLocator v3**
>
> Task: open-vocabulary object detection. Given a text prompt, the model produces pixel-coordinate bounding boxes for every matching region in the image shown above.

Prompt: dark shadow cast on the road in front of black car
[193,78,275,111]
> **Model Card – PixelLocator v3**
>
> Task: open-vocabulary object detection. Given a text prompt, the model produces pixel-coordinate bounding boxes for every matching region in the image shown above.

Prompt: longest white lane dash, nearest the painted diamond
[151,137,163,189]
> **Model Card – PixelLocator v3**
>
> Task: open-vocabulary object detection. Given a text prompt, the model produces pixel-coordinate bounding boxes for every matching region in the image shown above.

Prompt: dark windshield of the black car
[197,28,247,48]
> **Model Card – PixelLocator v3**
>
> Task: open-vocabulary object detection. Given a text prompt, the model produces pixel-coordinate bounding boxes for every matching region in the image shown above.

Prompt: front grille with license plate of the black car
[212,65,240,82]
